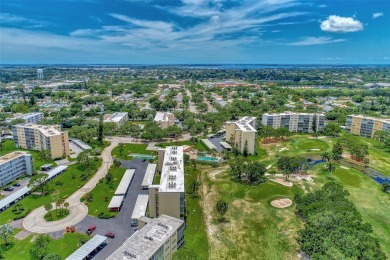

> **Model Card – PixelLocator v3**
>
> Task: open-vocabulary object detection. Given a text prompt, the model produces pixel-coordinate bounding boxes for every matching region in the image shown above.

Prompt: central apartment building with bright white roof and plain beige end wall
[149,146,185,219]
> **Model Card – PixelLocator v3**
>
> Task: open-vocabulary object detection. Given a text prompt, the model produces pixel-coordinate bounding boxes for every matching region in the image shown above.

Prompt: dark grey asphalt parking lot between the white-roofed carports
[76,159,148,259]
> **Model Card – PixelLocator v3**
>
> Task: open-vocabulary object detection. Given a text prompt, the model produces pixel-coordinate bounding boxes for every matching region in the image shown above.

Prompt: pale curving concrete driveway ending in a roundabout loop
[23,140,118,233]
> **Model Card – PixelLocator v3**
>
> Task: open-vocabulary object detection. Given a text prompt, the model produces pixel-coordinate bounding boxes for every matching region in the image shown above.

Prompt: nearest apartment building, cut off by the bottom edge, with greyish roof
[107,215,185,260]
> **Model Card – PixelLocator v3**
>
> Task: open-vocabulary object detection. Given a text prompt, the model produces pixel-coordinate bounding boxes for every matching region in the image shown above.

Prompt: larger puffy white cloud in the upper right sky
[321,15,363,33]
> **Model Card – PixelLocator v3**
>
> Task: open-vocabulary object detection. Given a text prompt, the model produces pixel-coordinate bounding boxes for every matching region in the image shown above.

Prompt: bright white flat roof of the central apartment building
[159,146,184,192]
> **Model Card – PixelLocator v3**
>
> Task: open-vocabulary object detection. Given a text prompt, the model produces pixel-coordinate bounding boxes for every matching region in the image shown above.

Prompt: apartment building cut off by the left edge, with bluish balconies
[0,151,34,186]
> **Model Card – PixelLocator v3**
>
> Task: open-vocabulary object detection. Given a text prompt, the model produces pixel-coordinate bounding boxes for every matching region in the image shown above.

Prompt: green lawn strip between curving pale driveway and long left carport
[0,160,101,224]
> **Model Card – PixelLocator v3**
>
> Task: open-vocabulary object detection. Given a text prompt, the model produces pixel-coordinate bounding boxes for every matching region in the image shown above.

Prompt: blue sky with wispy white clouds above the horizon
[0,0,390,64]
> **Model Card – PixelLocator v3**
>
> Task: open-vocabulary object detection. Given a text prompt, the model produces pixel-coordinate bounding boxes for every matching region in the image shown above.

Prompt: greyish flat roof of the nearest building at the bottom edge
[106,215,184,260]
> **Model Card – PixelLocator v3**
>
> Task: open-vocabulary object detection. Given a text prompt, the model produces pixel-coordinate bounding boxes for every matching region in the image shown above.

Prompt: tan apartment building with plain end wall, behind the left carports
[12,124,70,159]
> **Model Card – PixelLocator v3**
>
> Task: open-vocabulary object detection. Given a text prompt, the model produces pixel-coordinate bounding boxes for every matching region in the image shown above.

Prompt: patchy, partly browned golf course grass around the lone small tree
[202,169,301,259]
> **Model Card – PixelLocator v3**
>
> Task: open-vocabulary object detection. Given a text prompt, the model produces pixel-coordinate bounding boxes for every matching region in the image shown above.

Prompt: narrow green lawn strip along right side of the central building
[184,165,209,259]
